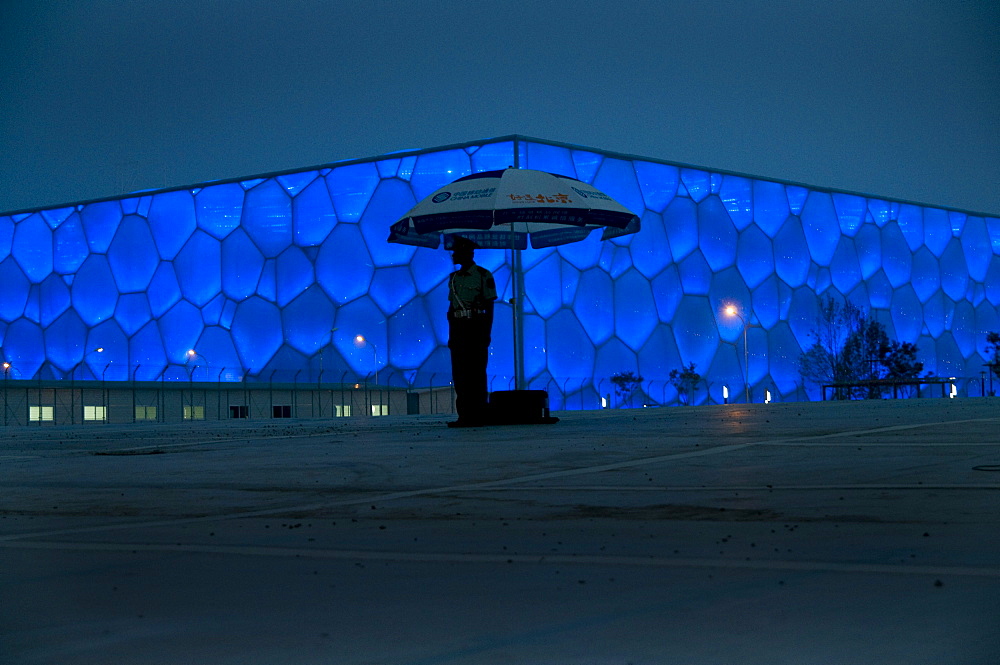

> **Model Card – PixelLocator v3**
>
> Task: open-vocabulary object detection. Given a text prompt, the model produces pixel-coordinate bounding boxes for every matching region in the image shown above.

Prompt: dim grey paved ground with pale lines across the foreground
[0,398,1000,665]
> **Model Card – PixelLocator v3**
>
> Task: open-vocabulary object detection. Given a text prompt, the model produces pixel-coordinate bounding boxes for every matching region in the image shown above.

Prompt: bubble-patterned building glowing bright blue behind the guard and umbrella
[0,136,1000,408]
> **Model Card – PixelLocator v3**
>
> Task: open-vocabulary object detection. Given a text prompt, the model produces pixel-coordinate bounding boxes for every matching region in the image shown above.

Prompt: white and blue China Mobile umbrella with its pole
[389,168,639,389]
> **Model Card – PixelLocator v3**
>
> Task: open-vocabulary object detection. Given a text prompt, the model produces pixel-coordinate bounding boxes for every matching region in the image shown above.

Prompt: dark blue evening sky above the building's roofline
[0,0,1000,214]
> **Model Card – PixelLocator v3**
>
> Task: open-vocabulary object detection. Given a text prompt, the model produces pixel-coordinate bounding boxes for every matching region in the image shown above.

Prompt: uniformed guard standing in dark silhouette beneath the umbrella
[448,237,497,425]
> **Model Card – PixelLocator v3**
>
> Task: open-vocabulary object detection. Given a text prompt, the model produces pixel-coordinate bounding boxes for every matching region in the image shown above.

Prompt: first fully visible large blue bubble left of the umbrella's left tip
[316,224,374,303]
